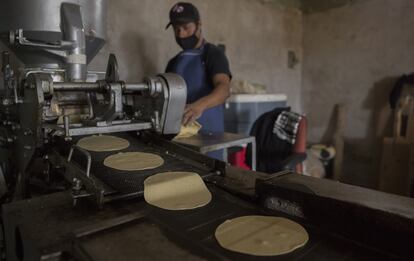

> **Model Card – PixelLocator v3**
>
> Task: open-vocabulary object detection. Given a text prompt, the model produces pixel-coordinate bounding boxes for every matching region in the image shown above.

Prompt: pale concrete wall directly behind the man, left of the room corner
[91,0,302,110]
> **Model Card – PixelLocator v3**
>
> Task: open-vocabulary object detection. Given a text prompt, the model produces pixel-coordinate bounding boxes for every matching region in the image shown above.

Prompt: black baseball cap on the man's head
[165,2,200,29]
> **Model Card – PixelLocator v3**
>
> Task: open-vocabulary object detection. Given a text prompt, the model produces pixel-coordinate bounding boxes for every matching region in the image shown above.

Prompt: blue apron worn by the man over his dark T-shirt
[174,46,224,160]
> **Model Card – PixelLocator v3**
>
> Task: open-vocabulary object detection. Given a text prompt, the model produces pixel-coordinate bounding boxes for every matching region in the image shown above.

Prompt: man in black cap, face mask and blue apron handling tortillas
[166,3,232,159]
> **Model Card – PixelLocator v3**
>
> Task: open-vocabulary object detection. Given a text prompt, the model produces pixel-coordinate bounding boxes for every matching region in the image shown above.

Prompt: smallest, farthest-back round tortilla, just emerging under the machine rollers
[78,135,129,152]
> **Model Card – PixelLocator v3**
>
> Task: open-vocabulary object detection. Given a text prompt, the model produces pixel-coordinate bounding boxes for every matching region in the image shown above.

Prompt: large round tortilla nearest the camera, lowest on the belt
[215,216,309,256]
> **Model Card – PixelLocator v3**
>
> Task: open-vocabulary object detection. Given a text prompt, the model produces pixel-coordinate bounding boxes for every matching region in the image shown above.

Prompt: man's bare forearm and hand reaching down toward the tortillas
[183,73,230,125]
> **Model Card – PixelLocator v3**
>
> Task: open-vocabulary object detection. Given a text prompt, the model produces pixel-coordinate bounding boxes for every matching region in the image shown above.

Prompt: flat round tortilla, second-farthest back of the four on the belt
[104,152,164,171]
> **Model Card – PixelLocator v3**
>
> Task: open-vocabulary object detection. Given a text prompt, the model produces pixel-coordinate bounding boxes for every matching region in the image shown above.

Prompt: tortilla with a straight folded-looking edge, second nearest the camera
[144,172,211,210]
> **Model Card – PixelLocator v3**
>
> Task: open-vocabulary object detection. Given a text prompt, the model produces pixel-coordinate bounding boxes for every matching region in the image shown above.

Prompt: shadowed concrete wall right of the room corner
[302,0,414,186]
